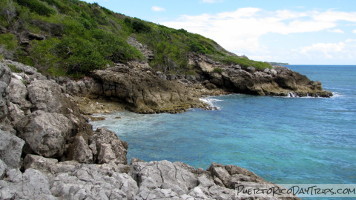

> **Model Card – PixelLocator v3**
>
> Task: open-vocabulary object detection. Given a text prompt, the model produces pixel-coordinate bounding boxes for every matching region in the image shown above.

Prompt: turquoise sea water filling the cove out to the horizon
[93,66,356,184]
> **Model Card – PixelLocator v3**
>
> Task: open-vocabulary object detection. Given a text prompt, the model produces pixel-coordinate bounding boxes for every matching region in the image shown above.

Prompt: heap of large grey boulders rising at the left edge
[0,61,127,164]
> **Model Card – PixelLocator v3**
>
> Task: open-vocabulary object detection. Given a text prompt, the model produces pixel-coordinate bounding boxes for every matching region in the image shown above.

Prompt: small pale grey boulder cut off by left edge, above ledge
[0,130,25,168]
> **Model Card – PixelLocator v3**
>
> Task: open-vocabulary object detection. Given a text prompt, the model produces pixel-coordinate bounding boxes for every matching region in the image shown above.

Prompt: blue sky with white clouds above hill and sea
[85,0,356,65]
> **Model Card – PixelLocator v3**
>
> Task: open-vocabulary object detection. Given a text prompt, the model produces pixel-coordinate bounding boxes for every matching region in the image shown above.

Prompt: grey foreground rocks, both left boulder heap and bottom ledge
[0,61,296,200]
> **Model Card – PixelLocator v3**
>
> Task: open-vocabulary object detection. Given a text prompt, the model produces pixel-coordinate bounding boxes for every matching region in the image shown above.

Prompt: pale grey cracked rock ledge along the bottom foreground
[0,155,297,200]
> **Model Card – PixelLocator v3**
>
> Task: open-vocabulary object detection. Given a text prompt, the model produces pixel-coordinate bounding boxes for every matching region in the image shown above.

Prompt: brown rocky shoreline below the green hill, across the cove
[56,55,332,114]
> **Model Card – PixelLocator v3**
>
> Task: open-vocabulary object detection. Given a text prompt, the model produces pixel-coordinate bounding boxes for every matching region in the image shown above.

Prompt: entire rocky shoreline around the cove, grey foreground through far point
[0,60,331,199]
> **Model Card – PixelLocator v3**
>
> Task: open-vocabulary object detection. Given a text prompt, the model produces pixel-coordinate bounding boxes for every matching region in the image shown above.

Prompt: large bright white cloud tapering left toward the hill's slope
[161,8,356,53]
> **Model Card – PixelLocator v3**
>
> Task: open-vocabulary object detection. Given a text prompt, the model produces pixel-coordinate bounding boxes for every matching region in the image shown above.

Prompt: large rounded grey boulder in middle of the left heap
[16,110,73,157]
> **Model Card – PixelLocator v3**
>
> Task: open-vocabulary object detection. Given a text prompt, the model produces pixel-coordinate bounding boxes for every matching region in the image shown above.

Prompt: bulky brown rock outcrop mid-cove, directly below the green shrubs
[93,63,207,113]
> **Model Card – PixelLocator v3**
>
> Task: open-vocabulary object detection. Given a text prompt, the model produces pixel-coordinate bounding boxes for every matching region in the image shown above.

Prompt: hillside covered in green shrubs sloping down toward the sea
[0,0,270,75]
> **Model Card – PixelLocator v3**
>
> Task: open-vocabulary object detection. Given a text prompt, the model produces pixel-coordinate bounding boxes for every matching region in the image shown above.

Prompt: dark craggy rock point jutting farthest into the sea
[189,55,332,97]
